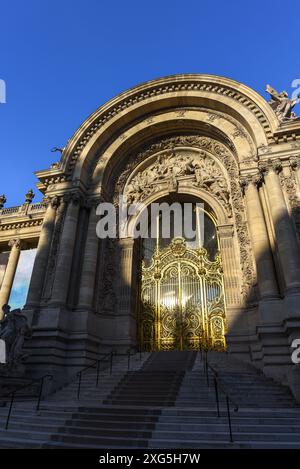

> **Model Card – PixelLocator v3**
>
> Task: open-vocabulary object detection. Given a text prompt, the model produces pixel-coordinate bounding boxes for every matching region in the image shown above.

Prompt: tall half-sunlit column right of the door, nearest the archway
[242,175,278,299]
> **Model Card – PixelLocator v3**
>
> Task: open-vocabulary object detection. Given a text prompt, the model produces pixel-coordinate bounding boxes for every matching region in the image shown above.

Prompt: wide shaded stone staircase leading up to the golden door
[0,352,300,449]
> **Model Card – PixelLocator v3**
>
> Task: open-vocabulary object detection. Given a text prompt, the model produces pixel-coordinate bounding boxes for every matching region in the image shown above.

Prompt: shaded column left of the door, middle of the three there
[50,194,80,305]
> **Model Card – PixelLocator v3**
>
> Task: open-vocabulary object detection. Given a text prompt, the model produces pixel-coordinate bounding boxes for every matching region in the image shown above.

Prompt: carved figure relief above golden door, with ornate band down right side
[112,135,255,299]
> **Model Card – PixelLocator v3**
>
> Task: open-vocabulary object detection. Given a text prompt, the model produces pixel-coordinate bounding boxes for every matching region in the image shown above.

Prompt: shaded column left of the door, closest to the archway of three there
[78,204,99,309]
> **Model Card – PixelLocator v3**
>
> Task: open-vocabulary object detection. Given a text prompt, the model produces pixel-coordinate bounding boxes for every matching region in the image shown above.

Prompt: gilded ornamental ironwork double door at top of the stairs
[138,238,226,351]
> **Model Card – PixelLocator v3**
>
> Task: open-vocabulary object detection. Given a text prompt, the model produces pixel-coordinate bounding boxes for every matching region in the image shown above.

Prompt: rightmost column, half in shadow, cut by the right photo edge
[261,160,300,290]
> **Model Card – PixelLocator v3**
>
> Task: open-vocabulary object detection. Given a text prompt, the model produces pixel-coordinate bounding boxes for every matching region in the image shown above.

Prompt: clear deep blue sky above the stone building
[0,0,300,206]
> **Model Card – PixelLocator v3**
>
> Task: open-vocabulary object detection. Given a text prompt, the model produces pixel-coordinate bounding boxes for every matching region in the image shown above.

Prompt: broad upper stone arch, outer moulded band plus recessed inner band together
[41,74,279,194]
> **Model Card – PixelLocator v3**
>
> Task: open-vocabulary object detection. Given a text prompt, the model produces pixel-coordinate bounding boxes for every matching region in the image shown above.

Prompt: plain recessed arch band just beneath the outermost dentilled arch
[85,110,257,192]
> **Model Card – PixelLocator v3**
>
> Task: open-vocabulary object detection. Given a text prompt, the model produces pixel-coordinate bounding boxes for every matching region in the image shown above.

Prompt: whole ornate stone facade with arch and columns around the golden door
[0,75,300,392]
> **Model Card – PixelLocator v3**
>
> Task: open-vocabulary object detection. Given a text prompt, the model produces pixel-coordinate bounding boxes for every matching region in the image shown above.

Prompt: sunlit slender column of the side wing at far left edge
[0,239,21,319]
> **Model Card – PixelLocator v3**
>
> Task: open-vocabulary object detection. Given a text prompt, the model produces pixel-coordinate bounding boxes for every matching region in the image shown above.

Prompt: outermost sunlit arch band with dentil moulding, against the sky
[58,74,278,182]
